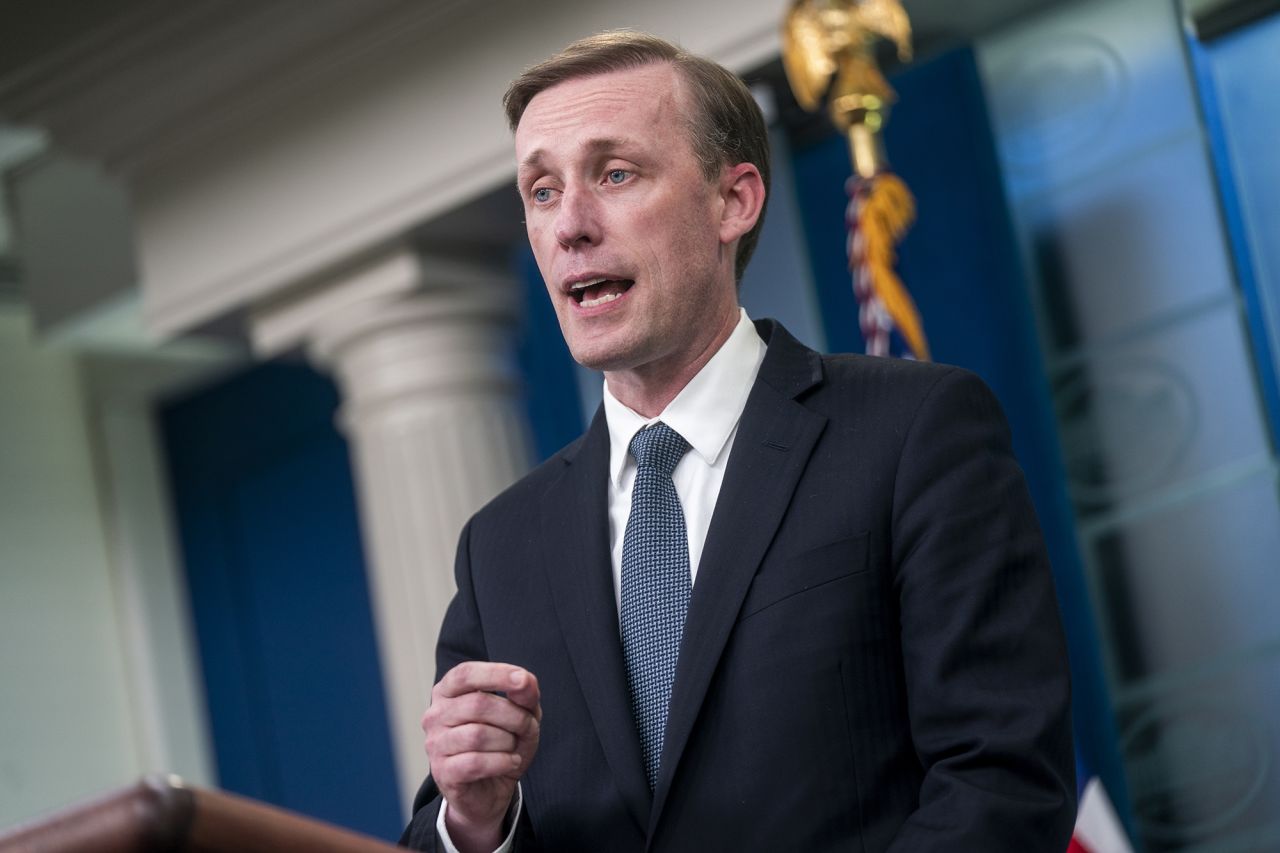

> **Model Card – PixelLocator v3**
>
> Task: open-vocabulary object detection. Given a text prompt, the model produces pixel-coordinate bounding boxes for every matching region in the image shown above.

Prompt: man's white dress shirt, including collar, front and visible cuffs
[435,309,765,853]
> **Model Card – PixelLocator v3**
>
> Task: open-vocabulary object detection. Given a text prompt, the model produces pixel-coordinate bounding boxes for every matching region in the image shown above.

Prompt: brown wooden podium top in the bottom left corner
[0,776,401,853]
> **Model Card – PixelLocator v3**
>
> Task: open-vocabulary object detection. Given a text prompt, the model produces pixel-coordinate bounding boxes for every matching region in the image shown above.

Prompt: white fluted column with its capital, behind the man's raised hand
[255,248,530,808]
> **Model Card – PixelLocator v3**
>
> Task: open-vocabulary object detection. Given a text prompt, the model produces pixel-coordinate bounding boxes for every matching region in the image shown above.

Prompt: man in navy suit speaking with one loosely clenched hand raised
[402,32,1074,853]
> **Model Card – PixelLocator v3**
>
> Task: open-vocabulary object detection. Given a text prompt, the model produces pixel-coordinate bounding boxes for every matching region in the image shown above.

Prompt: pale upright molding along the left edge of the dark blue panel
[82,352,239,785]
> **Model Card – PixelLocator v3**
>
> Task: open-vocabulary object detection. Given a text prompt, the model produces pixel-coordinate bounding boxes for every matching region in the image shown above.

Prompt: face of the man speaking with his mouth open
[516,64,737,371]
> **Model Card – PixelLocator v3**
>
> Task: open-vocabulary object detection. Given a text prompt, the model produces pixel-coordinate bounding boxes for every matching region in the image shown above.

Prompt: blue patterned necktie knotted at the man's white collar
[621,421,691,789]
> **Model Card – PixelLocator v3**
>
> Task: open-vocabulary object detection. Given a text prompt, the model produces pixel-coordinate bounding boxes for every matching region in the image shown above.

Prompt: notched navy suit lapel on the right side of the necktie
[650,321,827,839]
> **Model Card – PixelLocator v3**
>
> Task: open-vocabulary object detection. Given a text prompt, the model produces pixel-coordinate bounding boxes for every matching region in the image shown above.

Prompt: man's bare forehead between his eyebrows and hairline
[516,64,684,160]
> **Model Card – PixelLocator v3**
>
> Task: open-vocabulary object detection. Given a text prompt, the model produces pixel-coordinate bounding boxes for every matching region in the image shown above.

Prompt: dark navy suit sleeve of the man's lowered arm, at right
[891,370,1075,853]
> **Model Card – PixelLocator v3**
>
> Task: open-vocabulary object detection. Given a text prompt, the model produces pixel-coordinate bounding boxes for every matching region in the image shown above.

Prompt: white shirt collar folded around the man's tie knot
[604,309,765,488]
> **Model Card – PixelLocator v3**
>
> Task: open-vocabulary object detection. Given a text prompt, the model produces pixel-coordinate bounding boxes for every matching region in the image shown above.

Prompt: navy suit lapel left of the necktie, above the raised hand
[543,409,652,827]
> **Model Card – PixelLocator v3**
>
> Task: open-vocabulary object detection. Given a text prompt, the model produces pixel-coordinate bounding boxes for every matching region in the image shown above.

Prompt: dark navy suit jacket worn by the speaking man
[402,321,1075,853]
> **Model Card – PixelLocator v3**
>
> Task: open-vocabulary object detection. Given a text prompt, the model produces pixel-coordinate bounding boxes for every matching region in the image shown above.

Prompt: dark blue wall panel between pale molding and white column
[161,364,403,839]
